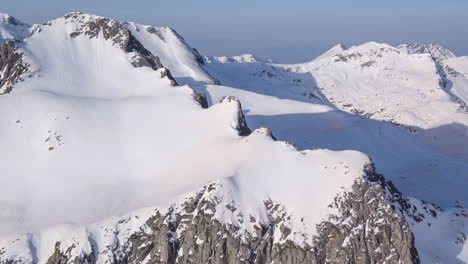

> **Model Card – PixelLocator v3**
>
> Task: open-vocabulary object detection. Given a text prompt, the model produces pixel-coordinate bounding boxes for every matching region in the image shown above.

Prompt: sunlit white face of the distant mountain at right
[298,43,468,160]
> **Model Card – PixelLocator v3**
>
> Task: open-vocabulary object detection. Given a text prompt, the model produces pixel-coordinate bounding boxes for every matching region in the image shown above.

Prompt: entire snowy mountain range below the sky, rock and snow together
[0,12,468,263]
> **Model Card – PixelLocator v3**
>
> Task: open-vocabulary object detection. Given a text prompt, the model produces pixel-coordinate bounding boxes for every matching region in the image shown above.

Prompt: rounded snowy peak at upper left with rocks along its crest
[2,12,186,98]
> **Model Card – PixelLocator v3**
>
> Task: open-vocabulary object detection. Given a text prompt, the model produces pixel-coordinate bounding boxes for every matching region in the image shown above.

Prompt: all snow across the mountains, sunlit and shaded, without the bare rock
[0,11,468,263]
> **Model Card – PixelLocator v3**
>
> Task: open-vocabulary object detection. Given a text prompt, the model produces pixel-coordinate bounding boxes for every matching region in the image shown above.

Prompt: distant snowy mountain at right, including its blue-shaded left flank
[202,43,468,160]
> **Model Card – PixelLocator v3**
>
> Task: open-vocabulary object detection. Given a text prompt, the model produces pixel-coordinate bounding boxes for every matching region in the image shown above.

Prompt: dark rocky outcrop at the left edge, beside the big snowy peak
[0,41,29,94]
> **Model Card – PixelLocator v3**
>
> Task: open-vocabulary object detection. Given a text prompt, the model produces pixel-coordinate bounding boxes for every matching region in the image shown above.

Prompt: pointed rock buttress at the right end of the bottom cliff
[314,164,419,263]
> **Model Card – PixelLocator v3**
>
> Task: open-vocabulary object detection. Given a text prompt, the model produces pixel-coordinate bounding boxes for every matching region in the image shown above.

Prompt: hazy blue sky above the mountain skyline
[0,0,468,63]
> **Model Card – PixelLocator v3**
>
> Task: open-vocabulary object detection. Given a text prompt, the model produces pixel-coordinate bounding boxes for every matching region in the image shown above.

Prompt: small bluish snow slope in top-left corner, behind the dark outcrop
[0,12,29,43]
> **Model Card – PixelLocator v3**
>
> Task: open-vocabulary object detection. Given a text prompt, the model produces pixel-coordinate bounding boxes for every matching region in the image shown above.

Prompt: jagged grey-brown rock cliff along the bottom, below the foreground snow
[19,164,419,264]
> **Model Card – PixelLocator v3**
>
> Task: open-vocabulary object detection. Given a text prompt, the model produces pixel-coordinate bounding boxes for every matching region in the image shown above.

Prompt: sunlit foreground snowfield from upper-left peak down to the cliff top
[0,12,369,240]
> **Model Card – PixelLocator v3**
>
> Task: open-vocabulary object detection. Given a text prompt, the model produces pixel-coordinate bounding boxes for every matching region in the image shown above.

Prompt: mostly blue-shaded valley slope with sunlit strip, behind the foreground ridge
[206,85,468,207]
